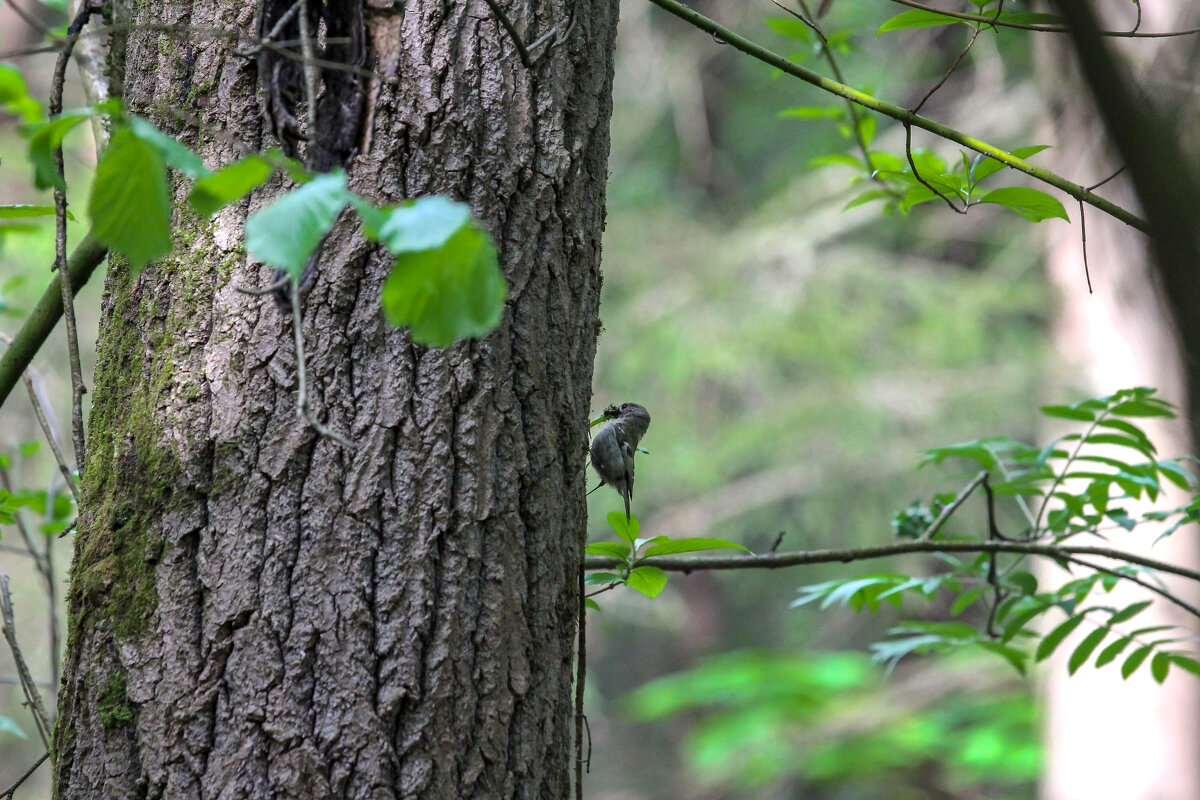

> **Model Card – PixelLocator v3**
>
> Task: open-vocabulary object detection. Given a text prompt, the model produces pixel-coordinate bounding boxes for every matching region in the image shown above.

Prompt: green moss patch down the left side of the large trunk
[68,241,212,646]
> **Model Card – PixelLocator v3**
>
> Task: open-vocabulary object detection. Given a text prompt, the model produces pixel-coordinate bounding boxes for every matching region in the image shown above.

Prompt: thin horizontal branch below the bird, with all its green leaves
[584,387,1200,681]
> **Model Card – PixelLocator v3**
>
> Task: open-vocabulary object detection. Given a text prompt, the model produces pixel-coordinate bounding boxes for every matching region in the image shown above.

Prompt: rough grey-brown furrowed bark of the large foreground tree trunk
[54,0,617,800]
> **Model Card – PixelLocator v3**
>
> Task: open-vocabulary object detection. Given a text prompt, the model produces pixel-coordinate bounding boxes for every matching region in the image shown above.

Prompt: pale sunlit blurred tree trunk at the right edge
[1043,2,1200,800]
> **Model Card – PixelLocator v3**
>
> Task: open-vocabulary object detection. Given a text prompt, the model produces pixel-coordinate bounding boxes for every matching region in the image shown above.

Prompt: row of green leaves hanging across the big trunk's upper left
[0,77,508,347]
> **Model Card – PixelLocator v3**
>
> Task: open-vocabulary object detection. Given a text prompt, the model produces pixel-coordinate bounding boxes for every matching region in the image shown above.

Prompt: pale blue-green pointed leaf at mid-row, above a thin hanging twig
[246,169,350,281]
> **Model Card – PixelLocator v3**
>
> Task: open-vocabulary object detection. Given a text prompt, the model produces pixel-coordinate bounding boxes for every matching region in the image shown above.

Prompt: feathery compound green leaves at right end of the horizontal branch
[793,387,1200,682]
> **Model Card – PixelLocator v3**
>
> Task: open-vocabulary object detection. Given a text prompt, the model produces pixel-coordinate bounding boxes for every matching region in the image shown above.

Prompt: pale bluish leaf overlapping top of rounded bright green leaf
[354,194,470,255]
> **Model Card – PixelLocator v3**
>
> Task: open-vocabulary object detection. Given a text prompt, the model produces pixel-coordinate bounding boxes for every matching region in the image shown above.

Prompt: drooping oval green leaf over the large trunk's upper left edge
[88,127,170,270]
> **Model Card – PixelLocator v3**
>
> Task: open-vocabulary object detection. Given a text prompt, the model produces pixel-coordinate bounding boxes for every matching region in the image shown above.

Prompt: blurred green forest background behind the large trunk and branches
[0,0,1066,800]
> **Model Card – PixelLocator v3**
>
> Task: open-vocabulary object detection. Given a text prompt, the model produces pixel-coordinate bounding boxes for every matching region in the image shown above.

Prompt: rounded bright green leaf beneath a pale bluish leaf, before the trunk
[383,225,508,347]
